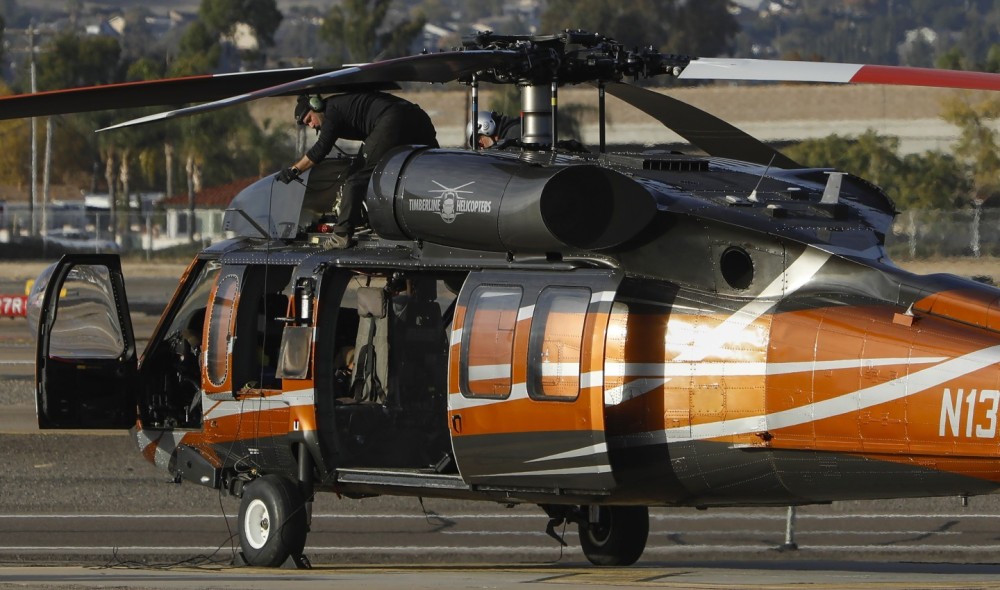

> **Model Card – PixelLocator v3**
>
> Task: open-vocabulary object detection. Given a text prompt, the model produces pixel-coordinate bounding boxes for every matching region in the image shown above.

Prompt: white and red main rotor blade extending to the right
[678,58,1000,90]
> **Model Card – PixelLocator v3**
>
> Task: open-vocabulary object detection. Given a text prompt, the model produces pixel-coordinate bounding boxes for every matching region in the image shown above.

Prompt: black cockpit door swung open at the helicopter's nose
[35,254,138,429]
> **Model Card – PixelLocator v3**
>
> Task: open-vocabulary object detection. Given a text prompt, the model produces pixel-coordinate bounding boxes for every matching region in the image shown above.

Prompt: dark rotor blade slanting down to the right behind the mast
[606,83,802,168]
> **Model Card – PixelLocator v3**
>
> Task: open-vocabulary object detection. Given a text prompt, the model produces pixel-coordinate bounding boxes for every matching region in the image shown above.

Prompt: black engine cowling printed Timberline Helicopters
[368,147,656,252]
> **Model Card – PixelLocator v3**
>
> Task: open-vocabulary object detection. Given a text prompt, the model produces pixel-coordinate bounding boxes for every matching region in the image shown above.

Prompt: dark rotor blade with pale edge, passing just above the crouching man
[98,50,522,131]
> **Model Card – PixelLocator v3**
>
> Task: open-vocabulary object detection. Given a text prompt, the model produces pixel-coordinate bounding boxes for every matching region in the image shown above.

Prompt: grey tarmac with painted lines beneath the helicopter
[0,267,1000,590]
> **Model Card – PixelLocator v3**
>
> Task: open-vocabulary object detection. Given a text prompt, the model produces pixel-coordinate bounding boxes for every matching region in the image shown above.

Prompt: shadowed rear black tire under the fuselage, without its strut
[580,506,649,566]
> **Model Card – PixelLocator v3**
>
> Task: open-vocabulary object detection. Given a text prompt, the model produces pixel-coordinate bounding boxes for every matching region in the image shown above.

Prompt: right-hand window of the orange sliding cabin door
[528,287,590,399]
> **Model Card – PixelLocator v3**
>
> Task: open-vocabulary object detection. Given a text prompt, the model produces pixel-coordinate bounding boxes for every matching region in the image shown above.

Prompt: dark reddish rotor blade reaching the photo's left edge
[0,67,378,119]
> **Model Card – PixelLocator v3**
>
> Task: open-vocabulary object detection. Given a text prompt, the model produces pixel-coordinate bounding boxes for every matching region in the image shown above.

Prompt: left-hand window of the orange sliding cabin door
[462,285,521,397]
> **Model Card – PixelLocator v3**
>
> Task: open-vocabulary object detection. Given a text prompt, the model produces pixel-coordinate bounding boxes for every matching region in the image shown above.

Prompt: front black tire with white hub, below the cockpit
[240,475,309,567]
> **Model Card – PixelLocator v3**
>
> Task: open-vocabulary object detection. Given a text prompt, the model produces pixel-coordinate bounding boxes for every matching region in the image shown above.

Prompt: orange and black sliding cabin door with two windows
[448,270,621,494]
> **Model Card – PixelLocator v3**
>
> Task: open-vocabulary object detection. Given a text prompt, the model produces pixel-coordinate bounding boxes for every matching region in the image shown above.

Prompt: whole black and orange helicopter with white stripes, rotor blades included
[9,32,1000,566]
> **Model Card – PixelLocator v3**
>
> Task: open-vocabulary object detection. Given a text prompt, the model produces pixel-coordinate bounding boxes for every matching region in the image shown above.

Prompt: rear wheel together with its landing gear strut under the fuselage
[542,505,649,566]
